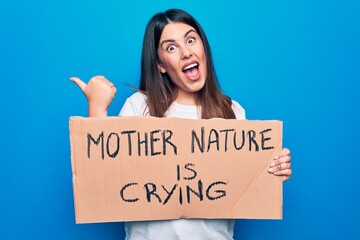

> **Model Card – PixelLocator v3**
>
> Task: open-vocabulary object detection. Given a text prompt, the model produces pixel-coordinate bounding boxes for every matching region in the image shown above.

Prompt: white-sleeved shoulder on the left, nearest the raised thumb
[119,92,148,116]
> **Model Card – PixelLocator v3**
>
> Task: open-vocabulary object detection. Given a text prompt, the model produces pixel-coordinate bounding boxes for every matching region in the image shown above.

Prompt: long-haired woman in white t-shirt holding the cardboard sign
[71,9,291,240]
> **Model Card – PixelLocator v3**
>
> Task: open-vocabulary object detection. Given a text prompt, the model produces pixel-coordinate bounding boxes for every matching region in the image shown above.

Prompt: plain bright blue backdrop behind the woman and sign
[0,0,360,240]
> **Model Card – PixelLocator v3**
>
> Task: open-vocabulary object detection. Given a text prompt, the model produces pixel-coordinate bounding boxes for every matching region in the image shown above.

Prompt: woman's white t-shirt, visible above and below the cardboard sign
[119,92,245,240]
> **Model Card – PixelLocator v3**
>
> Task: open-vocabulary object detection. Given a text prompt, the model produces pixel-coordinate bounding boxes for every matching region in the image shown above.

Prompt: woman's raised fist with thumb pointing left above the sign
[70,76,116,117]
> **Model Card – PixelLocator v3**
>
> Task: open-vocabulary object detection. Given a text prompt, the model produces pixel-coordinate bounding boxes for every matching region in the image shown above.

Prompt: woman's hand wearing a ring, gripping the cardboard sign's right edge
[268,148,292,181]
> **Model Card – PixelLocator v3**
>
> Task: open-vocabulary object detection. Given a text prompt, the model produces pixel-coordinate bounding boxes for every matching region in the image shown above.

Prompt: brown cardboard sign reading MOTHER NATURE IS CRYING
[70,117,282,223]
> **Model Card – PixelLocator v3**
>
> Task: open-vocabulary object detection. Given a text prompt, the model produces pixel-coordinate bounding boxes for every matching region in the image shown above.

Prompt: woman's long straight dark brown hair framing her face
[140,9,235,119]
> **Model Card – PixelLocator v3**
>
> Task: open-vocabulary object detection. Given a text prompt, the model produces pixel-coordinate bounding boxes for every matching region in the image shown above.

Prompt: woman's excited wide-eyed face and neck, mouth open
[157,22,207,104]
